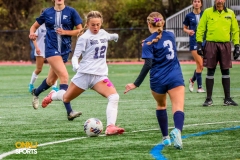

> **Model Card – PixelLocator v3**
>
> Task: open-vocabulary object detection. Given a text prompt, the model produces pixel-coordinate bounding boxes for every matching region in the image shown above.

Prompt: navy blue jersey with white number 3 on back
[142,31,184,86]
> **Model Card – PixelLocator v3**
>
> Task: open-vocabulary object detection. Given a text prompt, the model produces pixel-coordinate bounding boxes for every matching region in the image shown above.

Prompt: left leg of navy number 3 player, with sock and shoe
[152,91,171,146]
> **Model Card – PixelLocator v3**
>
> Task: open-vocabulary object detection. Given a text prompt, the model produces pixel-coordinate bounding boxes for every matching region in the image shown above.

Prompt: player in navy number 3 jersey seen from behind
[124,12,185,149]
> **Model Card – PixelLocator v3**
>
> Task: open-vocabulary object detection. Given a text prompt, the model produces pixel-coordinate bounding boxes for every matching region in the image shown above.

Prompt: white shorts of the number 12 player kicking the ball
[71,72,108,90]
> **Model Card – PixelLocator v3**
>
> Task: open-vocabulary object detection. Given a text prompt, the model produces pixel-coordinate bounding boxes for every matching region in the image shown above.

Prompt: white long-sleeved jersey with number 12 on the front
[73,29,118,75]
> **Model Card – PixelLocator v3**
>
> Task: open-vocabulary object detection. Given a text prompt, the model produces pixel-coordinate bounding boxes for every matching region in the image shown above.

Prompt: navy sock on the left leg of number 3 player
[156,109,168,137]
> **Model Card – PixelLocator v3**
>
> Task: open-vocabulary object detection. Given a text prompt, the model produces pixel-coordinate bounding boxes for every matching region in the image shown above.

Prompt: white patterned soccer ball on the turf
[84,118,103,137]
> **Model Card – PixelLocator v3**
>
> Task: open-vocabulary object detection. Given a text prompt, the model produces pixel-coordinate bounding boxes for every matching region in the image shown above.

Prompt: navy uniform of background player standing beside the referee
[183,11,203,50]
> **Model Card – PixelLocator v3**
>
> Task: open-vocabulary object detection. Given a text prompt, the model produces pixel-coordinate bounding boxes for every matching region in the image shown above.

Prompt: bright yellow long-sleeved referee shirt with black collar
[196,6,239,45]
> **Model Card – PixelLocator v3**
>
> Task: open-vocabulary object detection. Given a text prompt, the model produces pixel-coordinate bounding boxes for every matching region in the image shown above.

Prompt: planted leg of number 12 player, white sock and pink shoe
[93,79,125,135]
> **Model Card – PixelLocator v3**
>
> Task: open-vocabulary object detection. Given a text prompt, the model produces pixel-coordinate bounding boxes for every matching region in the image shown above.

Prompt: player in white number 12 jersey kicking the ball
[42,11,124,135]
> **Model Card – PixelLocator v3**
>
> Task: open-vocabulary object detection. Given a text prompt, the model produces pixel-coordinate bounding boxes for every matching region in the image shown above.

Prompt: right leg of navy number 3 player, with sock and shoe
[168,86,184,149]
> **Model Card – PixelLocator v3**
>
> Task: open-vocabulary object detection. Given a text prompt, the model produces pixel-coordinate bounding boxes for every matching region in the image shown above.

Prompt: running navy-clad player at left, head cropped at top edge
[29,0,82,120]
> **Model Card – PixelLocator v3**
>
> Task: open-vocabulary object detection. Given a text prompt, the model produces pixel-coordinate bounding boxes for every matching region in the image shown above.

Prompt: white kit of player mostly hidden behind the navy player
[34,23,47,58]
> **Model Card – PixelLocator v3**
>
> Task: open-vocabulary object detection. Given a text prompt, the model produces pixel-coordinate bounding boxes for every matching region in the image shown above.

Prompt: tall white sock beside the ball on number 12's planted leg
[106,93,119,126]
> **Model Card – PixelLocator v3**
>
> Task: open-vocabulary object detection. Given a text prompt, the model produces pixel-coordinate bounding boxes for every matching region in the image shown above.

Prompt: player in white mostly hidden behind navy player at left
[28,9,58,93]
